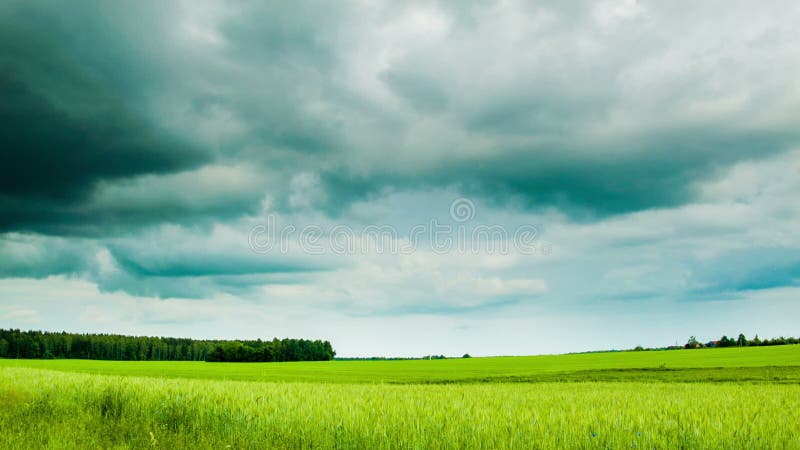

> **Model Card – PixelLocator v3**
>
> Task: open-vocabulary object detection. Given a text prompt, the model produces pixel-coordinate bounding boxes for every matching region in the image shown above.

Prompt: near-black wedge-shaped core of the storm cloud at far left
[0,73,205,200]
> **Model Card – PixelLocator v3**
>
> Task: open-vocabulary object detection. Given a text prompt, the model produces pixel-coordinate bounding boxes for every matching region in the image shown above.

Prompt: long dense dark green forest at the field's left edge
[0,329,336,362]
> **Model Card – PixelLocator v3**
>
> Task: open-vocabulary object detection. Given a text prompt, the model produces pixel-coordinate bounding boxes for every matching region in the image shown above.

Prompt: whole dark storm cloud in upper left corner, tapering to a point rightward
[0,0,210,230]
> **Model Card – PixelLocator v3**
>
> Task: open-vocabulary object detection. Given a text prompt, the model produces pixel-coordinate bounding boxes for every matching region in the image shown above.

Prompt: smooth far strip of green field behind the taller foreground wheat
[0,345,800,384]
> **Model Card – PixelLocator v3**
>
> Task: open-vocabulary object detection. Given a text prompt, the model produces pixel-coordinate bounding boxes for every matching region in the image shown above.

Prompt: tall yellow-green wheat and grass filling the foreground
[0,348,800,449]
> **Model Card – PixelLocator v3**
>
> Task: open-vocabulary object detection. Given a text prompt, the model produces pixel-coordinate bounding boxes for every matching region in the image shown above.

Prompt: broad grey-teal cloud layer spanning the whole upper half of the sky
[6,2,800,234]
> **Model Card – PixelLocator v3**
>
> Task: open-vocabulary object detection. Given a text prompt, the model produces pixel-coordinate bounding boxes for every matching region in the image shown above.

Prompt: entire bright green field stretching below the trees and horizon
[0,345,800,448]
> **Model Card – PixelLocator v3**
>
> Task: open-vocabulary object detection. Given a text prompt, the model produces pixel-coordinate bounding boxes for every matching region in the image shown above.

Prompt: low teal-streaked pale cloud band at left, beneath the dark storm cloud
[0,226,334,298]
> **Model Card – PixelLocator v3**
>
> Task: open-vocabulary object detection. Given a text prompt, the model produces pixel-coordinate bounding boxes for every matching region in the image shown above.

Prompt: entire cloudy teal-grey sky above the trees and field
[0,0,800,356]
